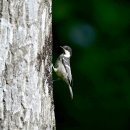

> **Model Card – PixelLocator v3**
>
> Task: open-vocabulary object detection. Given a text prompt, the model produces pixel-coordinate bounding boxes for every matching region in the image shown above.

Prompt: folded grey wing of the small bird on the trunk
[62,57,72,85]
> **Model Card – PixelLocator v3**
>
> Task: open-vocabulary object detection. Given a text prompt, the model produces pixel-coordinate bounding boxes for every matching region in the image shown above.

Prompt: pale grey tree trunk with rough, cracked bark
[0,0,55,130]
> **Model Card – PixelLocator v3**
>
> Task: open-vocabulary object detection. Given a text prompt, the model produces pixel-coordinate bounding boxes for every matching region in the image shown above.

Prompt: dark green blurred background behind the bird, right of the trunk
[52,0,130,130]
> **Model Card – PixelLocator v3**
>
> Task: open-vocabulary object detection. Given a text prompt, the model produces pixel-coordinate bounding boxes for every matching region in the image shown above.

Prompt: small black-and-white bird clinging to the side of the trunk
[52,46,73,99]
